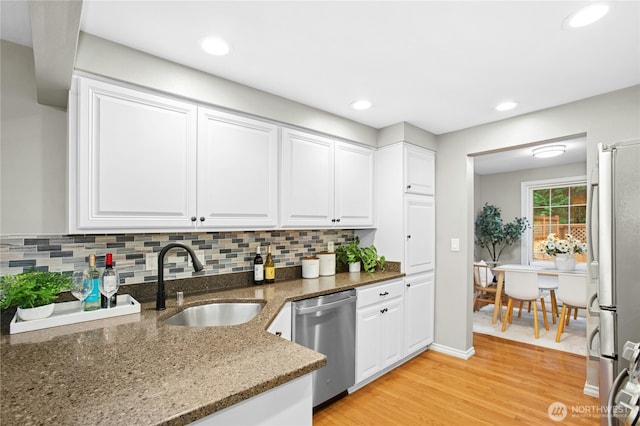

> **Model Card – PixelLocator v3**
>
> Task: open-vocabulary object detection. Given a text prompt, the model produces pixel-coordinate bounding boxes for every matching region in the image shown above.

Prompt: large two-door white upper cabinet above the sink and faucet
[69,77,278,232]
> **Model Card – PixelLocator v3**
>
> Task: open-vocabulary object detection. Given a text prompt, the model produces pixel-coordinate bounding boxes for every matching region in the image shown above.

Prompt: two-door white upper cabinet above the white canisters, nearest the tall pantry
[280,128,374,228]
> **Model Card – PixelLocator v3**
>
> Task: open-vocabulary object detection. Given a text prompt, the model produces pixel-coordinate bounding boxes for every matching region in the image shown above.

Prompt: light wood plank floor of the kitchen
[313,334,600,426]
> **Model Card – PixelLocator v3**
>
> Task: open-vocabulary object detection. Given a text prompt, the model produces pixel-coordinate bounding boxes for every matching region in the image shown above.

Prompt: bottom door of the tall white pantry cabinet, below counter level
[404,273,434,356]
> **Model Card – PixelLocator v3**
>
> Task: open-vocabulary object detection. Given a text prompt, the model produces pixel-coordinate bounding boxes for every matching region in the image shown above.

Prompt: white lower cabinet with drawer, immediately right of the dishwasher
[356,279,404,384]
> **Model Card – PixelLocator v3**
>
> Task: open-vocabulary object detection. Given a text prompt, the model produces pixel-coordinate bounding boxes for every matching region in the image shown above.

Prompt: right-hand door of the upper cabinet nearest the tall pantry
[335,142,375,227]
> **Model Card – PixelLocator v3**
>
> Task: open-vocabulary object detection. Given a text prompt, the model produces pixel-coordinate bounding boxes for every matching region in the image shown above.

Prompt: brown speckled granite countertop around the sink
[0,271,404,425]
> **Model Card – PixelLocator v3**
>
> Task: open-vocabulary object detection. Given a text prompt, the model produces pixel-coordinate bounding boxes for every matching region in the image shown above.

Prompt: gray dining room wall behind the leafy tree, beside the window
[473,163,587,264]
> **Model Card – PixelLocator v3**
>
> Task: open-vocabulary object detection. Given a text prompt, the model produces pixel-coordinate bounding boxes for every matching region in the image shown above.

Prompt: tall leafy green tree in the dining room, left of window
[475,203,529,263]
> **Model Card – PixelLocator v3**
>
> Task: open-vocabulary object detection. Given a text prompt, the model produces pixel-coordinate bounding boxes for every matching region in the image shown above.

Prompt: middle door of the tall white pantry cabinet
[405,196,435,274]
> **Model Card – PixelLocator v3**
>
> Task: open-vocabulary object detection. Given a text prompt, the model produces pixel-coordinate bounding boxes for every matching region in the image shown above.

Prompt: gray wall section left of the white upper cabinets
[0,40,67,234]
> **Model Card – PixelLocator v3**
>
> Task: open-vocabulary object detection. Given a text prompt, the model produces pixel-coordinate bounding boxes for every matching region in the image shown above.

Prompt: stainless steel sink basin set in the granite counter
[164,302,264,327]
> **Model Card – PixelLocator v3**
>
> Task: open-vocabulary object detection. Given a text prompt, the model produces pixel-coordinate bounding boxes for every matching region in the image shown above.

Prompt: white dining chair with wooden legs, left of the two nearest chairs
[502,270,549,339]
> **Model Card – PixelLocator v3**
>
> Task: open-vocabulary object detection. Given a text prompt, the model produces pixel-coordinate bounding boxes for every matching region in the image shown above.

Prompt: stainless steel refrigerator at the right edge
[588,140,640,424]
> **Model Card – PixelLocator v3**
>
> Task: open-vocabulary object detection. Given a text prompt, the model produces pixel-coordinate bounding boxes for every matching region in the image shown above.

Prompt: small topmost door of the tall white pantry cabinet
[404,145,435,195]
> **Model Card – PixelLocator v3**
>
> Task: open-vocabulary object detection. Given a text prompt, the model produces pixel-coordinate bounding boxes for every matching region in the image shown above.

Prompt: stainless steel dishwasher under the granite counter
[292,290,356,407]
